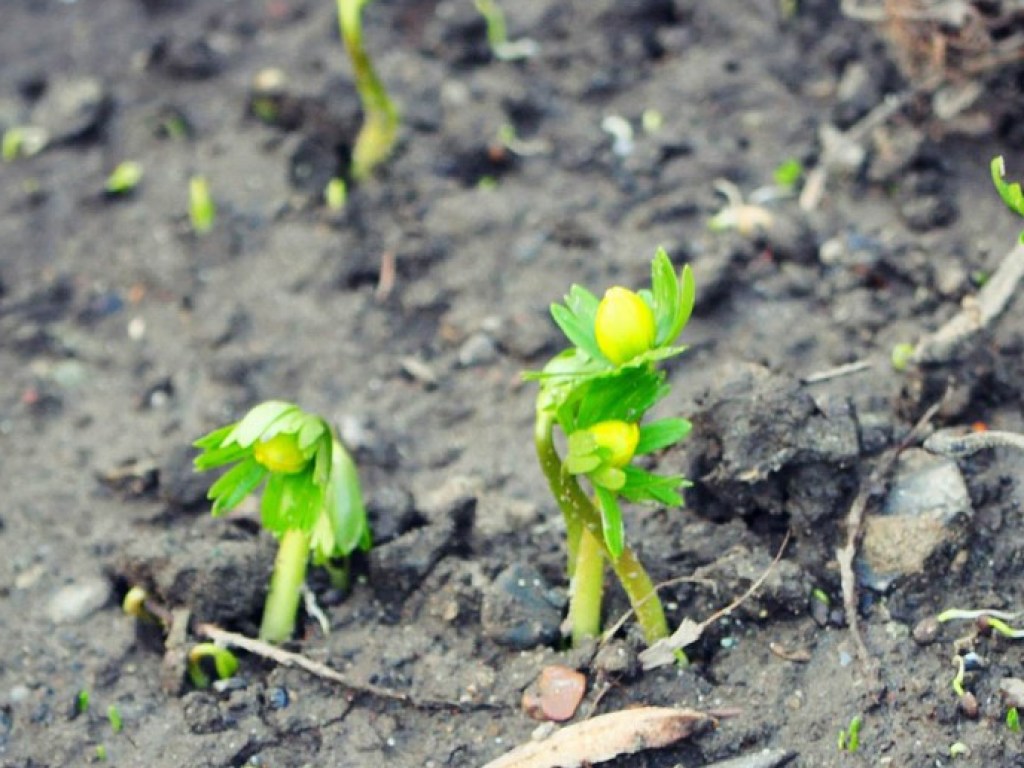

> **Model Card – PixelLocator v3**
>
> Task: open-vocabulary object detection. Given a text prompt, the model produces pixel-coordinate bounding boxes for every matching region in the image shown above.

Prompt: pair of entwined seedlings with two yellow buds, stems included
[526,249,694,644]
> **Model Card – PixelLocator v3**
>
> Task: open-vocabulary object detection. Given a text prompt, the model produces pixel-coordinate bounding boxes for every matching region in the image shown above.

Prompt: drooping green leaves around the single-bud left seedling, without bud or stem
[195,400,371,563]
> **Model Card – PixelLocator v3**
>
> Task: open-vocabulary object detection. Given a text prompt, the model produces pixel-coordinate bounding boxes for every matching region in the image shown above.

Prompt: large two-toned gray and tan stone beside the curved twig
[860,449,974,591]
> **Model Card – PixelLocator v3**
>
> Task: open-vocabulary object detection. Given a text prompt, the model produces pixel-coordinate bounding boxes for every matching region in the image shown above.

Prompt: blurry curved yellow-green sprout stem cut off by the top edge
[338,0,399,181]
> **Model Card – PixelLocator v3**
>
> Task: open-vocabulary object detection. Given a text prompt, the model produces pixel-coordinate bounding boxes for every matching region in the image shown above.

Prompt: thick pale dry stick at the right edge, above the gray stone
[913,243,1024,365]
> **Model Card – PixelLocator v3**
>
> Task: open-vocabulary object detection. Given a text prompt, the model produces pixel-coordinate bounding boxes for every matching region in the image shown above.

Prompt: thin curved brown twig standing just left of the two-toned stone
[836,388,952,676]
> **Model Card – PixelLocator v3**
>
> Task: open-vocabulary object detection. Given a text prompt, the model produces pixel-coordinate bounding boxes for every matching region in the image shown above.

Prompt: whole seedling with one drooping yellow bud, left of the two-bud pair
[196,400,371,643]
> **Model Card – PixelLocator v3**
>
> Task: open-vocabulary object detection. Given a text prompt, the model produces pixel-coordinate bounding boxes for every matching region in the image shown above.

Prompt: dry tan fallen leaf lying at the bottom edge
[483,707,716,768]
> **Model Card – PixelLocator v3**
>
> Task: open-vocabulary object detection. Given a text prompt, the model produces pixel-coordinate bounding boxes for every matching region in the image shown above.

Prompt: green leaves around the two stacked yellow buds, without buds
[526,249,695,558]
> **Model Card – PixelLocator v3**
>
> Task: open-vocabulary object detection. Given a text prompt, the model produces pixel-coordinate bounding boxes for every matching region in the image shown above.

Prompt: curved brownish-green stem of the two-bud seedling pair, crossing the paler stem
[534,409,669,645]
